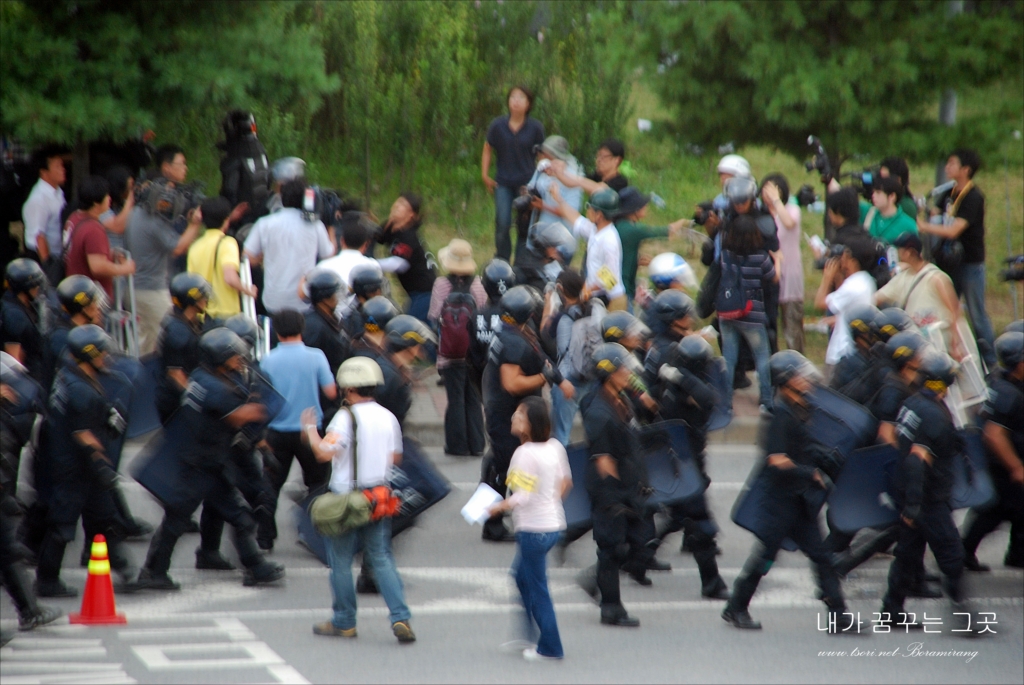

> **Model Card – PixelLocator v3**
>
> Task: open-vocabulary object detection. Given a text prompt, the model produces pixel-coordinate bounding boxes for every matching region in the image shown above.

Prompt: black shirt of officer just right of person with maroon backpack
[483,326,545,456]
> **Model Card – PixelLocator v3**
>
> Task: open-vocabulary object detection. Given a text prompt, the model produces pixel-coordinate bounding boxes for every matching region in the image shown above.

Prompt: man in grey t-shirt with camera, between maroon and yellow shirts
[125,145,203,355]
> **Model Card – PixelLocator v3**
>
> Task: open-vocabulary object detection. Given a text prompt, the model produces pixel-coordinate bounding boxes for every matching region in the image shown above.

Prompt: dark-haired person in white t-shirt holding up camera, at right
[814,239,878,368]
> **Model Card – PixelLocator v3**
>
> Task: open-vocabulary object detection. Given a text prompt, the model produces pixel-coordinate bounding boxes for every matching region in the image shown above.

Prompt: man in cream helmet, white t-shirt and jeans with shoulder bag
[302,356,416,642]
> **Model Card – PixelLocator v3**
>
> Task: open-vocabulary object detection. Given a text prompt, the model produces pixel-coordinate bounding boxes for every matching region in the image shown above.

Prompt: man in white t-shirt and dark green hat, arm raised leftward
[551,185,627,311]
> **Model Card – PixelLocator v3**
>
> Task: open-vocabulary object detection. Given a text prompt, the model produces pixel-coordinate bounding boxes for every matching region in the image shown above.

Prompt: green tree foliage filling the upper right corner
[631,0,1024,167]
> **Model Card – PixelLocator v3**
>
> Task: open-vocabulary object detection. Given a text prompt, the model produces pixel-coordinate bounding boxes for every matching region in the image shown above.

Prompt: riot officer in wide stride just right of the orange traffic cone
[138,328,285,590]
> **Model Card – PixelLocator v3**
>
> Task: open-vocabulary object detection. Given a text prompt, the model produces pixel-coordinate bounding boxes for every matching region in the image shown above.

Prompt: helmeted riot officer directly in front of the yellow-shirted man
[156,272,213,425]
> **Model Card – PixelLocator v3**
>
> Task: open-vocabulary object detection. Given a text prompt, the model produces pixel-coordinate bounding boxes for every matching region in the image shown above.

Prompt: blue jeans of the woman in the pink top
[512,532,564,658]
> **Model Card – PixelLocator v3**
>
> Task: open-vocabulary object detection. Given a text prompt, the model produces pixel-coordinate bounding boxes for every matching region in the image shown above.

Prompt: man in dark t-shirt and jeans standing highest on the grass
[480,86,544,261]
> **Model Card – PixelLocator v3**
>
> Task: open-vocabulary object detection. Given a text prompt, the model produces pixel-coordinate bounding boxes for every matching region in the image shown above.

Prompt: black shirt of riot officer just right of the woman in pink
[583,387,647,511]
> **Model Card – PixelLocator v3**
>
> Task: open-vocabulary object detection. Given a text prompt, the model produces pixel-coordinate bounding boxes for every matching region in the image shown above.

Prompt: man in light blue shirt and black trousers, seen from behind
[256,309,338,550]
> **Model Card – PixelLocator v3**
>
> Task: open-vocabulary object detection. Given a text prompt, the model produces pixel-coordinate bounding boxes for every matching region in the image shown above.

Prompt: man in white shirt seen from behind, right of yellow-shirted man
[245,178,334,314]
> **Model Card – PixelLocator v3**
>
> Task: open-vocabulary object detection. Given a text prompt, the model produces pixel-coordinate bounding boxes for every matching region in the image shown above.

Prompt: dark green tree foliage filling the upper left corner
[0,0,339,167]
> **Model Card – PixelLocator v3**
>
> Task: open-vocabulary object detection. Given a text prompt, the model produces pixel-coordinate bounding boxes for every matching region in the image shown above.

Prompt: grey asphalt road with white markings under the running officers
[0,438,1024,685]
